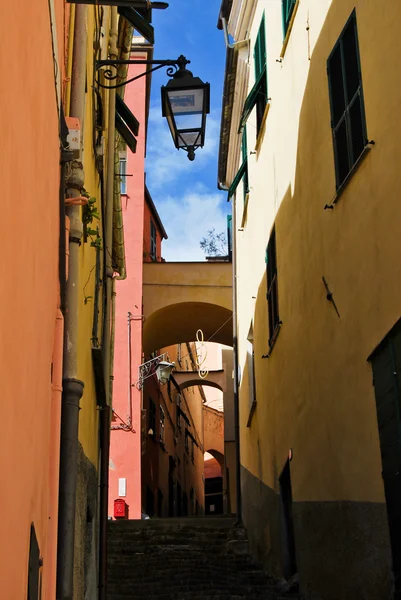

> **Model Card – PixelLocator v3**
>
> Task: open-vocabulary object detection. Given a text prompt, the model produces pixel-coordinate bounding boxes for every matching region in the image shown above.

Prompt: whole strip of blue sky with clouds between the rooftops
[146,0,230,261]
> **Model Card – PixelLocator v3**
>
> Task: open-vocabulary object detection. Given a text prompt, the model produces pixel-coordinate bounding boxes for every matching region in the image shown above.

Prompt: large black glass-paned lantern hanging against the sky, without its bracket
[161,55,210,160]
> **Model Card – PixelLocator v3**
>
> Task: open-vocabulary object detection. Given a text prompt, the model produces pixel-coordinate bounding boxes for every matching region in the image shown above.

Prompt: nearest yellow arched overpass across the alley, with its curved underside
[143,262,232,356]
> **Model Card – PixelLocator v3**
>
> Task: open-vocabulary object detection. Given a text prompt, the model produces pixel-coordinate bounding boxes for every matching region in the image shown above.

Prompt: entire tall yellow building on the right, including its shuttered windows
[219,0,401,600]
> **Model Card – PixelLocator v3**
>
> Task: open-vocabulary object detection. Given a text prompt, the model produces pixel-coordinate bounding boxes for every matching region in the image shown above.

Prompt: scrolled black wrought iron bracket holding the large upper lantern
[96,55,191,90]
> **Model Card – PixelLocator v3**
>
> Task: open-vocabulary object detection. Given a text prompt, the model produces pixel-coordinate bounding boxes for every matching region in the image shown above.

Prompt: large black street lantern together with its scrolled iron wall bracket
[96,55,210,160]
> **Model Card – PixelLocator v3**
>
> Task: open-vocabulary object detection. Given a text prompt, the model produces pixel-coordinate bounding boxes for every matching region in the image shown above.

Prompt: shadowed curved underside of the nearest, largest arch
[143,302,233,356]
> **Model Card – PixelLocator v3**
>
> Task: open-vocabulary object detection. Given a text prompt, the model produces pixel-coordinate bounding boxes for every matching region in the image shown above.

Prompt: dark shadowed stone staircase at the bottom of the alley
[107,517,300,600]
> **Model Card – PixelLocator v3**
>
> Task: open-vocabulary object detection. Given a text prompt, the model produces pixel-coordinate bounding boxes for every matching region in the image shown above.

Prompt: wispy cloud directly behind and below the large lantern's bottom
[146,107,220,193]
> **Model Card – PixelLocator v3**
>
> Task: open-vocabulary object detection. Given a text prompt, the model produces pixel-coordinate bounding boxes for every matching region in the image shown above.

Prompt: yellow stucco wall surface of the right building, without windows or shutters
[225,0,401,600]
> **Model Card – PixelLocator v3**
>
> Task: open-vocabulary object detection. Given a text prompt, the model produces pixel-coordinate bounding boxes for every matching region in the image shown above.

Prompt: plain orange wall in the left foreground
[0,0,63,600]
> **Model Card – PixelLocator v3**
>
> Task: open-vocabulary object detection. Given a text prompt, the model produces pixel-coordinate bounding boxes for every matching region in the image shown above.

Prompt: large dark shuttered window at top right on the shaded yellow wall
[327,11,367,189]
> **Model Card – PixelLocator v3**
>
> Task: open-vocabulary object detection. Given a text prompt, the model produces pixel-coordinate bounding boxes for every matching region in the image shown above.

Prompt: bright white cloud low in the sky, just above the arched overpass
[156,184,227,261]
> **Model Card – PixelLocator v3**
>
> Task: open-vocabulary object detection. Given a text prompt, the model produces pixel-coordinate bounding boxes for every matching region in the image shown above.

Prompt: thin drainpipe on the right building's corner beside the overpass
[217,182,242,525]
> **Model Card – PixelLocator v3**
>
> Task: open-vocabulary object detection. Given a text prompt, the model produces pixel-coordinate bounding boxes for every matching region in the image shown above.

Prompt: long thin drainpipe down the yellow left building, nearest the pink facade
[99,6,118,600]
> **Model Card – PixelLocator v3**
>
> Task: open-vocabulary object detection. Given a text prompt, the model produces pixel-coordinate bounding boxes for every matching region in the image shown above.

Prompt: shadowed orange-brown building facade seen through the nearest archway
[142,343,206,517]
